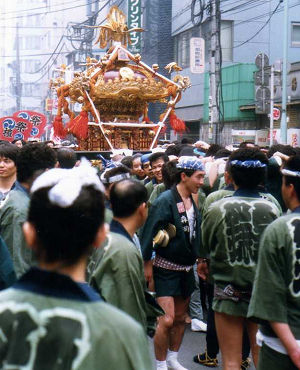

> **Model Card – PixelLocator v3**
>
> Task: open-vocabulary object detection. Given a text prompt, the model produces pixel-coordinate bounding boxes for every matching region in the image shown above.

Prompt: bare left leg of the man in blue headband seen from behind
[215,312,245,370]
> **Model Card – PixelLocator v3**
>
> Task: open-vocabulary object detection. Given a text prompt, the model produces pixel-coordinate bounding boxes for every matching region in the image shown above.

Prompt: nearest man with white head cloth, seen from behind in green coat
[0,160,152,370]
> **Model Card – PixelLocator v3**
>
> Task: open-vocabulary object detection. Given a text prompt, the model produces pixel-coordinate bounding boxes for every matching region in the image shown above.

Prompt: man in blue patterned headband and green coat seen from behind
[202,148,280,370]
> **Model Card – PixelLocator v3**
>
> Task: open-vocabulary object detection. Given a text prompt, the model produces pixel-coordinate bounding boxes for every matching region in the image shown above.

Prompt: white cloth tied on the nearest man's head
[31,158,104,208]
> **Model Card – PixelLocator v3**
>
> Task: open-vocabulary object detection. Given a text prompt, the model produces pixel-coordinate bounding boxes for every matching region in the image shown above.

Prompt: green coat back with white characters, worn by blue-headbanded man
[203,192,280,289]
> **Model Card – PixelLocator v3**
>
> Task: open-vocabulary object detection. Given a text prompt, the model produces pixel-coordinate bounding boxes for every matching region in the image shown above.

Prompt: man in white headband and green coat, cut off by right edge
[248,156,300,370]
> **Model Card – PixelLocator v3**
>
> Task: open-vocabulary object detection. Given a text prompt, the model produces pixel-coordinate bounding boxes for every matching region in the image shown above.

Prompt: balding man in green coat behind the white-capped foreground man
[91,179,163,336]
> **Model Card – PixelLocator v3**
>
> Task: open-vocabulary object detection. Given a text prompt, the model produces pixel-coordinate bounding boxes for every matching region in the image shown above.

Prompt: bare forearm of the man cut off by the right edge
[270,321,300,369]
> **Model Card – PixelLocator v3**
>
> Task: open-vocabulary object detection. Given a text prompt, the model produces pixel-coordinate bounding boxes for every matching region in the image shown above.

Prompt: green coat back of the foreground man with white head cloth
[0,269,152,370]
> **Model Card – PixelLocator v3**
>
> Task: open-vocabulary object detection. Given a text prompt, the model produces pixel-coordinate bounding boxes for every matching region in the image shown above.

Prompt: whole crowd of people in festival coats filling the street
[0,138,300,370]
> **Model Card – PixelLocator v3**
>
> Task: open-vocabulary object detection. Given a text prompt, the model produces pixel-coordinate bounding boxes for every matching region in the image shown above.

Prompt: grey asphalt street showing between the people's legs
[150,325,255,370]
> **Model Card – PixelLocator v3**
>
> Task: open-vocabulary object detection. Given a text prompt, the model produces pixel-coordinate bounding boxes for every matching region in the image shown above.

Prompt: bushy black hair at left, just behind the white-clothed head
[16,143,56,182]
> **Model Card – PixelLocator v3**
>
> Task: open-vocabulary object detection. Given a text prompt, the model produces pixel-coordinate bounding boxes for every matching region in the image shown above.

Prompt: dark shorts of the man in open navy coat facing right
[153,266,195,298]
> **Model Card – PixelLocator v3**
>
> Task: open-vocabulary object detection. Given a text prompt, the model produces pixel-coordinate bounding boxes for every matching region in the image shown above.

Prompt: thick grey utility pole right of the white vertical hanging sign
[208,0,220,144]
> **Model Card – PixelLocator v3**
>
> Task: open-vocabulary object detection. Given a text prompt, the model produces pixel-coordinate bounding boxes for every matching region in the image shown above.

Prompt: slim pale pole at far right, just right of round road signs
[280,0,289,144]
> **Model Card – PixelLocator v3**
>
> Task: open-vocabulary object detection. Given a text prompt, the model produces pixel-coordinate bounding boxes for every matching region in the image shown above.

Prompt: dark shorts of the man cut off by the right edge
[257,343,297,370]
